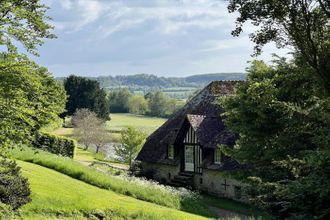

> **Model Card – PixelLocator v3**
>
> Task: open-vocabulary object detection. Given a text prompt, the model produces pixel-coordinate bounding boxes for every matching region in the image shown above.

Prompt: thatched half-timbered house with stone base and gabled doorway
[136,81,244,201]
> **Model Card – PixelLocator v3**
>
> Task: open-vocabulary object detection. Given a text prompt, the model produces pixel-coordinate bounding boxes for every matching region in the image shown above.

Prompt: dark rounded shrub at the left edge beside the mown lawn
[0,157,30,211]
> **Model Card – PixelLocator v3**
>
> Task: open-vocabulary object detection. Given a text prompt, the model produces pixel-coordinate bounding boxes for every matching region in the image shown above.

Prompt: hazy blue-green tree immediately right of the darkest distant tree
[109,88,132,113]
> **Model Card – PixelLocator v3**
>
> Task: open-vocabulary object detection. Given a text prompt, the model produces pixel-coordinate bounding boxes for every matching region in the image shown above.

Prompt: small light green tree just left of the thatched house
[115,127,146,167]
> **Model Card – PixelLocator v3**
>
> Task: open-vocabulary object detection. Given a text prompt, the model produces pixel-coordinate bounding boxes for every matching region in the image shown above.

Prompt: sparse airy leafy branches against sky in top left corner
[0,0,55,54]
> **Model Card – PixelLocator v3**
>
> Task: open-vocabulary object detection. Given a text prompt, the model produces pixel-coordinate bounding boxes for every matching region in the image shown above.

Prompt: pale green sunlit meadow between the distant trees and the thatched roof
[107,113,167,134]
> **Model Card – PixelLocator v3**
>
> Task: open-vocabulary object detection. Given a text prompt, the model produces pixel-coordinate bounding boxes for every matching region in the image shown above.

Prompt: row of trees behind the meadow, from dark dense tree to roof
[62,75,184,120]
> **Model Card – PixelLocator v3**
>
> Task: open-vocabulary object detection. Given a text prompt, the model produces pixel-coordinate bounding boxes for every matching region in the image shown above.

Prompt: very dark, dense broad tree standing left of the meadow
[64,75,110,120]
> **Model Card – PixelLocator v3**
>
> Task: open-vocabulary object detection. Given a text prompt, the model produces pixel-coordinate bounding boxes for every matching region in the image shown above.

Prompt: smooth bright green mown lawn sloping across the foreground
[18,161,203,219]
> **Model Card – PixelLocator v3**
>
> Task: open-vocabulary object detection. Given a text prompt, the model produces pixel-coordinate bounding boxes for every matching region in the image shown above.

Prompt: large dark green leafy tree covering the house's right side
[224,59,330,219]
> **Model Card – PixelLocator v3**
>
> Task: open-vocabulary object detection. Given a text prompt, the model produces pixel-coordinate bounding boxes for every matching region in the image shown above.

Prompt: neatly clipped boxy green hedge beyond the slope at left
[34,132,77,158]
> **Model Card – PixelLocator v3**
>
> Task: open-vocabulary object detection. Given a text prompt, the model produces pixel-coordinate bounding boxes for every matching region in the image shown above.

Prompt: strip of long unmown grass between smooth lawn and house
[10,148,212,217]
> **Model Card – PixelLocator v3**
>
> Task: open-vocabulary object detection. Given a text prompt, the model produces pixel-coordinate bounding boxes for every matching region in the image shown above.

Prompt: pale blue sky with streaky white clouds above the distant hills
[27,0,287,77]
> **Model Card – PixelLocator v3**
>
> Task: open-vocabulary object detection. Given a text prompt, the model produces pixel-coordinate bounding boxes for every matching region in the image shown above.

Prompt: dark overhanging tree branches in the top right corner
[228,0,330,94]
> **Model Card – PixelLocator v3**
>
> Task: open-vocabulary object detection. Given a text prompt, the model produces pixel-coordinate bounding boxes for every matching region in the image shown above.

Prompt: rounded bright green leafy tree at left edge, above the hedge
[0,53,66,153]
